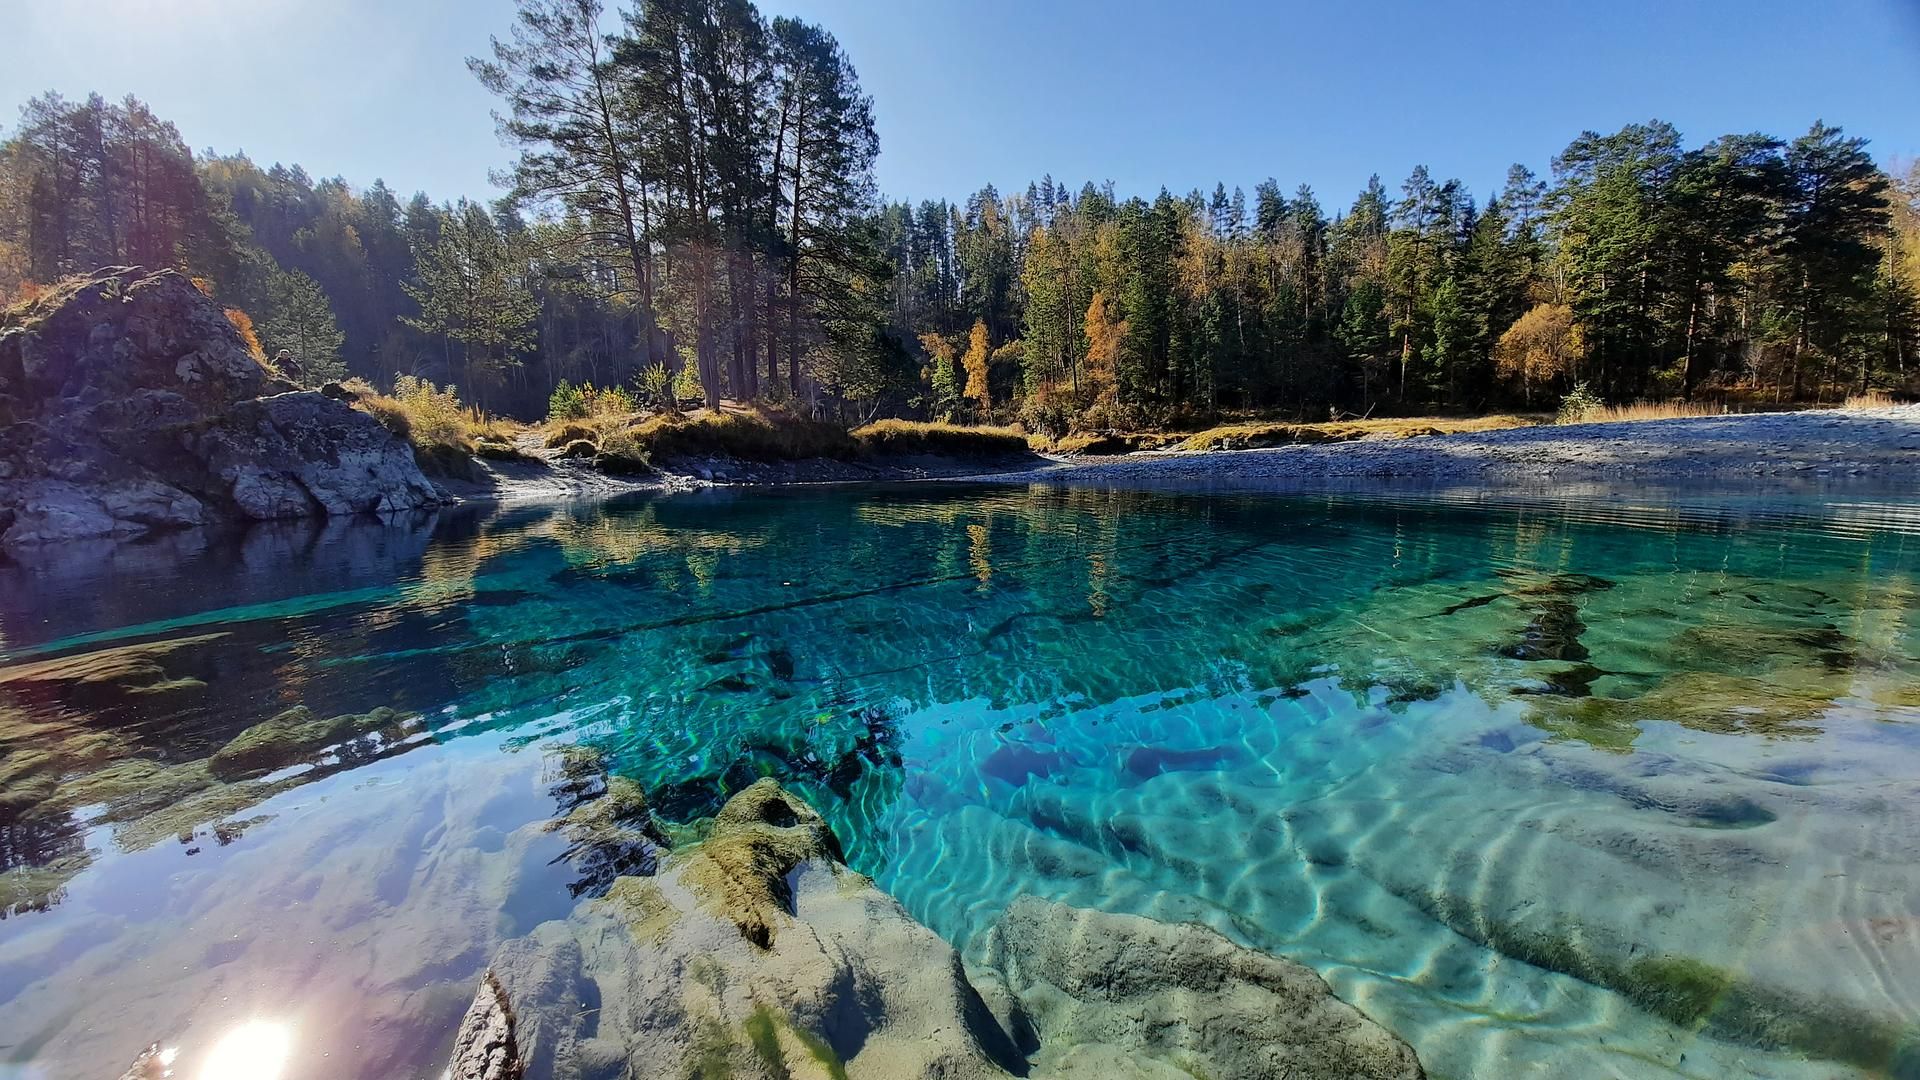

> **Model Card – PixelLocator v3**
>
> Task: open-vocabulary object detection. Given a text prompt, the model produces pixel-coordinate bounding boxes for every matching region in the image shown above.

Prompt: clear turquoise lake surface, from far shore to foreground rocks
[0,486,1920,1078]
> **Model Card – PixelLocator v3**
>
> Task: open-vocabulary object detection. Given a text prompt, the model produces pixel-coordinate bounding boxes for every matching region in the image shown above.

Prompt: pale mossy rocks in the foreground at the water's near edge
[449,780,1421,1080]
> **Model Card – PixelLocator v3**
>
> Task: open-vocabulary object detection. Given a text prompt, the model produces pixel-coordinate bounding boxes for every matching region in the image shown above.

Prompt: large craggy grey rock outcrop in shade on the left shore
[0,261,445,548]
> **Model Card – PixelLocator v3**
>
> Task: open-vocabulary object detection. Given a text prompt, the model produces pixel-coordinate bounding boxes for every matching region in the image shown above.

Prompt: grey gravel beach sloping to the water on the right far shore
[993,405,1920,488]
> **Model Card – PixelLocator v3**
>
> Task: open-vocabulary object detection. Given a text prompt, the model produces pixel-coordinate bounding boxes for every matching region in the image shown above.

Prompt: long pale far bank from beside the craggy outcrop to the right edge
[408,405,1920,503]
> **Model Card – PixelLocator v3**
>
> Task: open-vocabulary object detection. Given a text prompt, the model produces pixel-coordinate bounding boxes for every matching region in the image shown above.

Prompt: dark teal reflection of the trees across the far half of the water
[0,488,1920,907]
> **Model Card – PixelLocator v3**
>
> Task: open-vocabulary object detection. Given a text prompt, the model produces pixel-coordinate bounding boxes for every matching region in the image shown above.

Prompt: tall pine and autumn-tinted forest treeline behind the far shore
[0,0,1920,434]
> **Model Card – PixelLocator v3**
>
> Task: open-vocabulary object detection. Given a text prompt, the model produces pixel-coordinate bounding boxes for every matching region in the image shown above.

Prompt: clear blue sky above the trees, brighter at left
[0,0,1920,209]
